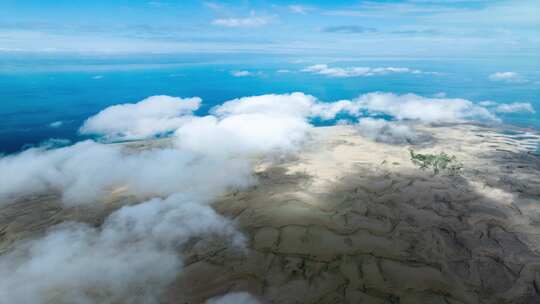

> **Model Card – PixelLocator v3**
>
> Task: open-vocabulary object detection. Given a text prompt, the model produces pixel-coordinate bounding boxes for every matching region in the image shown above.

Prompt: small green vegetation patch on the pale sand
[409,149,463,175]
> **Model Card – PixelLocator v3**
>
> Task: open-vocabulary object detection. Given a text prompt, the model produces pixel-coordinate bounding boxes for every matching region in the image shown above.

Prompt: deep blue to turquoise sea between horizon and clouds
[0,55,540,153]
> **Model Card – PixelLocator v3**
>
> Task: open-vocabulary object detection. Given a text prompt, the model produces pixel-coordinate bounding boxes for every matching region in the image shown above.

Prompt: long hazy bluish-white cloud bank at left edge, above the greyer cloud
[0,137,262,205]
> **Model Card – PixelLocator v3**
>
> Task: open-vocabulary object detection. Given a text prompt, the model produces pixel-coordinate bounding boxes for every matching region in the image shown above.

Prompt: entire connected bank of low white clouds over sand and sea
[0,93,534,303]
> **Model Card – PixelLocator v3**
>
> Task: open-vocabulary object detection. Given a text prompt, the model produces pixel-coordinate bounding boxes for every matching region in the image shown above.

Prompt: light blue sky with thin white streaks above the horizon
[0,0,540,58]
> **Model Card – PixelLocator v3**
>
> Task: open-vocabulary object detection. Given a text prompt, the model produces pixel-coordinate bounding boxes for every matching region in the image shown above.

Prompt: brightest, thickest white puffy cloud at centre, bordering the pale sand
[181,93,316,155]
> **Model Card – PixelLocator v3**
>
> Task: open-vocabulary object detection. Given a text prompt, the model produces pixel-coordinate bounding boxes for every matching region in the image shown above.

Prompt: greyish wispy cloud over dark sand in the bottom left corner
[0,195,243,304]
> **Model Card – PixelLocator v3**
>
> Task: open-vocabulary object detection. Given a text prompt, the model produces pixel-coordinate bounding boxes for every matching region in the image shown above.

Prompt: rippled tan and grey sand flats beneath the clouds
[0,125,540,304]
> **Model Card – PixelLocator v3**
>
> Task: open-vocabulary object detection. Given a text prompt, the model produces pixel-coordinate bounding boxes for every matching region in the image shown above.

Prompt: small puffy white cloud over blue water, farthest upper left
[79,96,201,140]
